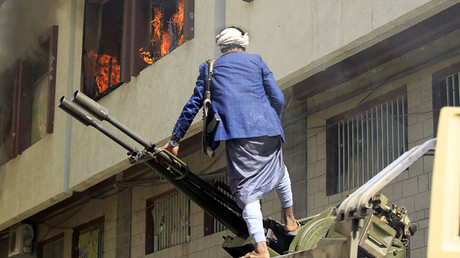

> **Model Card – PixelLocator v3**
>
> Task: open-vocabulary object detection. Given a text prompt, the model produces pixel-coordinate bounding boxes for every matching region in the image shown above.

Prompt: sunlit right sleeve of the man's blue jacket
[260,58,284,117]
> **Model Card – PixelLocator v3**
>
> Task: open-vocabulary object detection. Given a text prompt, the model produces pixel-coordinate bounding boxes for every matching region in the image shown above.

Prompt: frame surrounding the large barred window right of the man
[326,85,408,196]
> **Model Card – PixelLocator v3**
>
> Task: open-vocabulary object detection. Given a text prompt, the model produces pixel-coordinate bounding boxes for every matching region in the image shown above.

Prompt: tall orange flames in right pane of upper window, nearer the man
[139,0,184,64]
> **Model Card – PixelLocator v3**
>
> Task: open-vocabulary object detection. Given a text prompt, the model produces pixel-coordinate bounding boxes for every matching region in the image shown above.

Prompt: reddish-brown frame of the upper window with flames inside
[80,0,195,100]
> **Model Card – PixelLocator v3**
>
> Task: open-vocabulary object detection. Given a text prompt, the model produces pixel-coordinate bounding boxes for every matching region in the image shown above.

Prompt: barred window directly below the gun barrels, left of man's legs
[145,190,190,254]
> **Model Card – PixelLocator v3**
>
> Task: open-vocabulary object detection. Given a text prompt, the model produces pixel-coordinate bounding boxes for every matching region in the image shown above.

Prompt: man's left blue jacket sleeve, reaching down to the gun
[172,63,206,138]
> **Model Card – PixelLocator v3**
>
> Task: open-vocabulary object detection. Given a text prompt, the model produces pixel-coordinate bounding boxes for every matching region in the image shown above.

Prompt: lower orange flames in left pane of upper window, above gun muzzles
[88,50,120,93]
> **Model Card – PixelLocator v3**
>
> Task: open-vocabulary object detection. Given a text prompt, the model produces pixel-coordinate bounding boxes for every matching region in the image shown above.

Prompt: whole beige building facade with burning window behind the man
[0,0,460,257]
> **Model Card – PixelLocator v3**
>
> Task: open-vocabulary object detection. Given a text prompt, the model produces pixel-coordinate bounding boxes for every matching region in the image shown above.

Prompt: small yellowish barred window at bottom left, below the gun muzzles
[78,223,104,258]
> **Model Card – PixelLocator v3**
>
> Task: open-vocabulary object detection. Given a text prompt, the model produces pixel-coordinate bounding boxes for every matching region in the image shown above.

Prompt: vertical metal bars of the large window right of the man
[336,96,408,192]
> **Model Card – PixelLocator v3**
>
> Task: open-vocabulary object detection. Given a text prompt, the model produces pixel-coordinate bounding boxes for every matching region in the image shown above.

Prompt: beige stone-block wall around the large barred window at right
[298,26,460,257]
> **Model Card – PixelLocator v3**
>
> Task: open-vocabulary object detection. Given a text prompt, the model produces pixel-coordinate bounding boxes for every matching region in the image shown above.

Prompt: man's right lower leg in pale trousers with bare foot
[276,168,298,231]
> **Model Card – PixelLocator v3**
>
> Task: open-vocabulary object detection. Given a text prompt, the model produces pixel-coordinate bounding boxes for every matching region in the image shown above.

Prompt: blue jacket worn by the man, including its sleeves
[172,52,284,142]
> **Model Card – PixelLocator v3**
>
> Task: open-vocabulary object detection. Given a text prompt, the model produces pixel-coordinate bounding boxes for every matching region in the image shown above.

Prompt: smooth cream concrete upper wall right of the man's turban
[227,0,458,89]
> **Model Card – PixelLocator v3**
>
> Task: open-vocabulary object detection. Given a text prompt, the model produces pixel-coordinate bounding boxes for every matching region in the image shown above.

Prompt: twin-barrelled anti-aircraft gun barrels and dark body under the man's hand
[58,91,289,256]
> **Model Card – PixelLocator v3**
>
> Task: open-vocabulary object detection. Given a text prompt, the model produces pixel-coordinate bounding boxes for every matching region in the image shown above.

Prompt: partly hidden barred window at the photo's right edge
[432,63,460,135]
